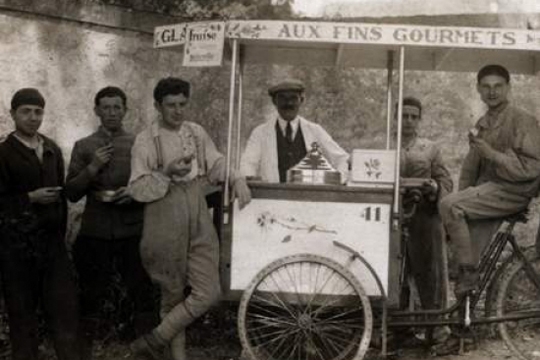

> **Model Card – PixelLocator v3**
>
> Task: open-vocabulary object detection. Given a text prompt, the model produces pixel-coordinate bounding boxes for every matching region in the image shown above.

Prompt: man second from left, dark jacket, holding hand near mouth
[66,87,152,357]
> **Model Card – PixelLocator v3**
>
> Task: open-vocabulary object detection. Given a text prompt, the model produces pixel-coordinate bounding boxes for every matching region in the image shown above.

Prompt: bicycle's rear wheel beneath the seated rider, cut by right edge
[495,258,540,360]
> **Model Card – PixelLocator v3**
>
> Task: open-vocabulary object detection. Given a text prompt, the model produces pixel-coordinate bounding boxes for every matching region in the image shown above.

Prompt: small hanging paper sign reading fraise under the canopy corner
[183,22,225,66]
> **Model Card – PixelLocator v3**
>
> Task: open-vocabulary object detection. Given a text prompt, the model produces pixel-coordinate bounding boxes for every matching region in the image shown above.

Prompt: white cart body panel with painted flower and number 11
[230,184,392,296]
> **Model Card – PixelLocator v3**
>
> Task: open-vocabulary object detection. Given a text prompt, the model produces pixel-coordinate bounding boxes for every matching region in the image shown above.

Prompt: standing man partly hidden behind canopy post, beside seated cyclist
[400,97,453,342]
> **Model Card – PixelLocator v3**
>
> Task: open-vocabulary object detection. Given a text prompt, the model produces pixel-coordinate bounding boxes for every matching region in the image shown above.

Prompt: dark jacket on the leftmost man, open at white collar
[0,133,67,234]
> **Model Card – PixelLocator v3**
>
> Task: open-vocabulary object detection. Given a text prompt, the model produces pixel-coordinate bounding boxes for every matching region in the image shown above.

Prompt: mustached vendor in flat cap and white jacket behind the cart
[241,79,349,183]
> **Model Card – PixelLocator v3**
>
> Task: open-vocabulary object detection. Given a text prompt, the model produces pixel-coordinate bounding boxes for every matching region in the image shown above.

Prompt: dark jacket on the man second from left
[66,128,143,239]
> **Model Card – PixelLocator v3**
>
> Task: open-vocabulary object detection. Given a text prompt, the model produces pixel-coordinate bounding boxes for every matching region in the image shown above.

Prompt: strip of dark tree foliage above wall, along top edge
[83,0,294,20]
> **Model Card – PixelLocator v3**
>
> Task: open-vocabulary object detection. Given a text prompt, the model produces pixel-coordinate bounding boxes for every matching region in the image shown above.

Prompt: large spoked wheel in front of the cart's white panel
[238,254,373,360]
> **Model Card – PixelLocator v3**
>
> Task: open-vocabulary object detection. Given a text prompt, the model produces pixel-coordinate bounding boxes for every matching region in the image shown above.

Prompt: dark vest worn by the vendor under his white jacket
[276,121,307,183]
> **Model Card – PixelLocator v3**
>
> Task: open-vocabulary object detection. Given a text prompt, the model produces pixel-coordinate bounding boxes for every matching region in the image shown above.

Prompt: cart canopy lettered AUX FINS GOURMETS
[154,20,540,74]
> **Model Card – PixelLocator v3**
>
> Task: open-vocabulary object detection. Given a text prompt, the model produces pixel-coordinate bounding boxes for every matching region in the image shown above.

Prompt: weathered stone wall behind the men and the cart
[0,1,540,245]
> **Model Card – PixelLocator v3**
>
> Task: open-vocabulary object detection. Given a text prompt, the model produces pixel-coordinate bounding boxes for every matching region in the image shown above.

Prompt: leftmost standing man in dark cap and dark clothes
[0,88,80,360]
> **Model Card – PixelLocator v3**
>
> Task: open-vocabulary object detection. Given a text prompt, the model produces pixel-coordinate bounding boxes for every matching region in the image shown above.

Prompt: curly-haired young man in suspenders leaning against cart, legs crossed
[130,77,251,360]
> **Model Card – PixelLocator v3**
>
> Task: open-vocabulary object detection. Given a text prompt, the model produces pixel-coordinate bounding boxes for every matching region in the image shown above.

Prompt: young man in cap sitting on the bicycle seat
[439,65,540,299]
